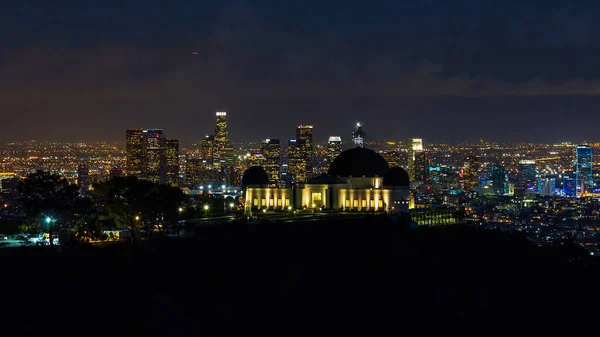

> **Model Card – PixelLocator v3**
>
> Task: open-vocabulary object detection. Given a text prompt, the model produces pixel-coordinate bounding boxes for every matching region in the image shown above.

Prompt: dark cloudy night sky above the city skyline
[0,0,600,142]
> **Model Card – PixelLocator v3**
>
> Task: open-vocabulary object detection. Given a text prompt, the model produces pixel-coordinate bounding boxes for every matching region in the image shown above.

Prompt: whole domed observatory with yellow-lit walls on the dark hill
[242,147,410,214]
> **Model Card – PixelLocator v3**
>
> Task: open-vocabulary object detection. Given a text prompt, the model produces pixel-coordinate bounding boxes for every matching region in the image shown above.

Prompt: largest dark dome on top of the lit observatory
[327,147,390,178]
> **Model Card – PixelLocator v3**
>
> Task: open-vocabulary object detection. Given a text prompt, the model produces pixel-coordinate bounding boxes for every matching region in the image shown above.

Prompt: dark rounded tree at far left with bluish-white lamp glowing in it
[19,171,78,245]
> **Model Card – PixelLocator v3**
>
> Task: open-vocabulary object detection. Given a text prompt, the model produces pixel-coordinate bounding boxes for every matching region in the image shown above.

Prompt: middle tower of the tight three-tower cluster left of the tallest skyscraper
[143,129,166,184]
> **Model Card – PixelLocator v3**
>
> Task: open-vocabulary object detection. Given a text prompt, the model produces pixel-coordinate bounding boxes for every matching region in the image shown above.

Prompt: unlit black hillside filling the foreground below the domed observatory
[0,218,600,336]
